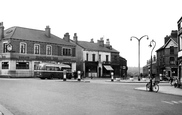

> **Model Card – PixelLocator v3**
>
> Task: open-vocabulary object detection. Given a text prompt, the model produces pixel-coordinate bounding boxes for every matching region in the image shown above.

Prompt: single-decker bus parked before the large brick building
[35,63,72,79]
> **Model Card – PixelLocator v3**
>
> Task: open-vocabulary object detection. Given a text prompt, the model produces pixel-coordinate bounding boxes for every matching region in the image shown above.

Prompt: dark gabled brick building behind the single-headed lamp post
[156,30,178,77]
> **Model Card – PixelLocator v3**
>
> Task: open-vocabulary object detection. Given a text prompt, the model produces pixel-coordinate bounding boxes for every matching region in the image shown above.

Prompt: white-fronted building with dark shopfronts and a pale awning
[73,33,127,77]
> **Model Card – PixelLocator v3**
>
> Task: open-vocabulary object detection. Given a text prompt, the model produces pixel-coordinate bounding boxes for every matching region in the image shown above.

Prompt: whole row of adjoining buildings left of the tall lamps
[0,23,127,77]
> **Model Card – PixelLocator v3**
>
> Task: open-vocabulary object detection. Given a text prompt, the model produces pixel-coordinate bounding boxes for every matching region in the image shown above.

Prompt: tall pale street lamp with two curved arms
[130,35,149,80]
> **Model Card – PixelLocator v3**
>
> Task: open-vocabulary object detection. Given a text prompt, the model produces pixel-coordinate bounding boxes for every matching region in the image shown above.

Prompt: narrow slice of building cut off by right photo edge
[177,17,182,81]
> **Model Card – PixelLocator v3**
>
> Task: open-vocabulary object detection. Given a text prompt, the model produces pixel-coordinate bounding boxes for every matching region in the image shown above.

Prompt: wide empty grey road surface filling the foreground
[0,78,182,115]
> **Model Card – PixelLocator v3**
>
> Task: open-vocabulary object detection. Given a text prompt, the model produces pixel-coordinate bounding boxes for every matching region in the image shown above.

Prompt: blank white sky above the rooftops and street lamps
[0,0,182,67]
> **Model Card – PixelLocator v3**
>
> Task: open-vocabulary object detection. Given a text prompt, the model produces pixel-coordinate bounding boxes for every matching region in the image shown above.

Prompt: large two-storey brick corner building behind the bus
[0,23,76,77]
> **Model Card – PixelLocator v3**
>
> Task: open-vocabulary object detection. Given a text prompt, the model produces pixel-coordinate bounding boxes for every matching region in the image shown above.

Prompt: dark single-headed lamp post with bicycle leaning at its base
[149,40,156,91]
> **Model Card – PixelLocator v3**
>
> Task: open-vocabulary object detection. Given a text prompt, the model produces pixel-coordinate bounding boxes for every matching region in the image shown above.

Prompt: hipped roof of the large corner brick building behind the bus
[4,27,75,46]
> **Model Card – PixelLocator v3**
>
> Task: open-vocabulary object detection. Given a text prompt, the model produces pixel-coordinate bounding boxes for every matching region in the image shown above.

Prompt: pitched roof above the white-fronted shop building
[78,41,119,53]
